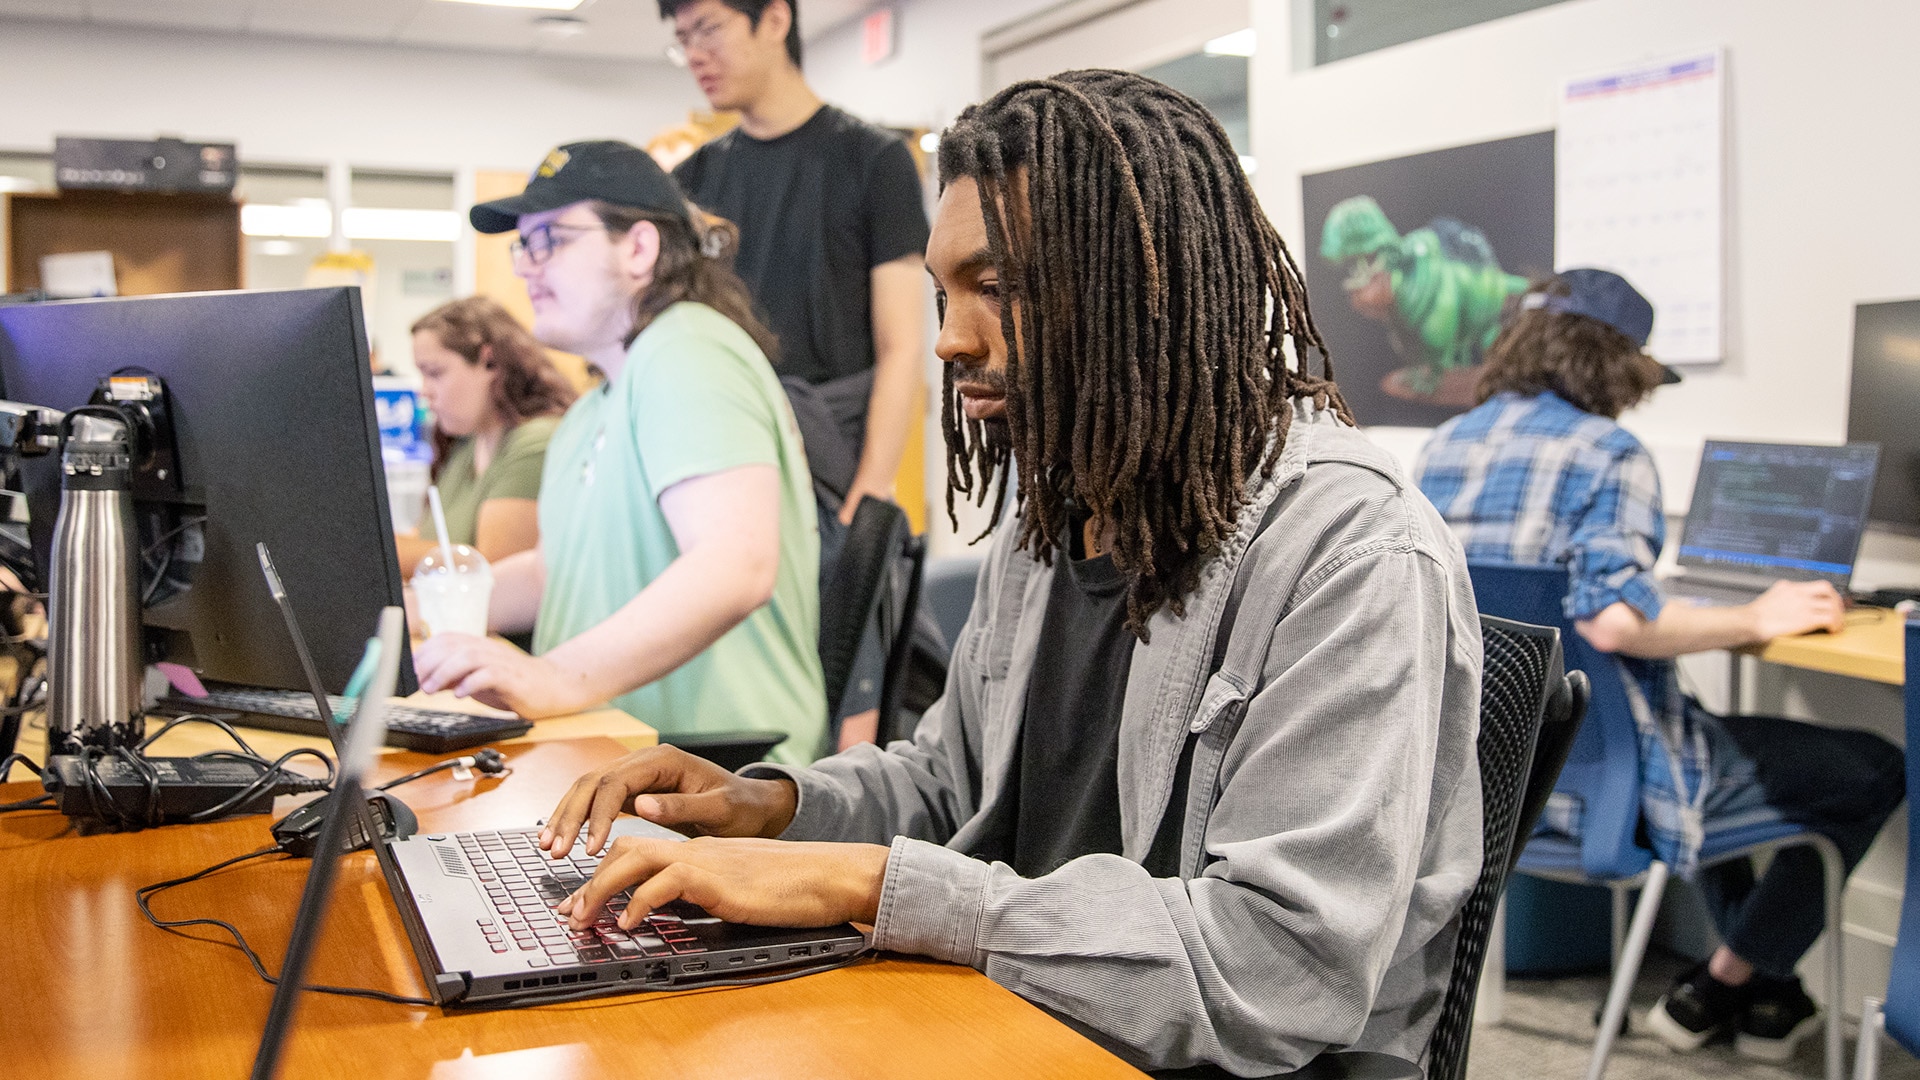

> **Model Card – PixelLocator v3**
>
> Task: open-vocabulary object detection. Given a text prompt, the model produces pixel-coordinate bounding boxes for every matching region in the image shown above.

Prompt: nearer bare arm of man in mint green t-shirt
[415,465,780,719]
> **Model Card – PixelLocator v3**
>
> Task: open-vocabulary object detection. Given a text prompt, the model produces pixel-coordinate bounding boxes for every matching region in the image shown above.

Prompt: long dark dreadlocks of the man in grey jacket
[939,71,1354,642]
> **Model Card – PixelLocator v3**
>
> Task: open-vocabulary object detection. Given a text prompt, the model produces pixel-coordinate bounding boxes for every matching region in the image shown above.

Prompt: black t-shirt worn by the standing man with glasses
[674,106,927,384]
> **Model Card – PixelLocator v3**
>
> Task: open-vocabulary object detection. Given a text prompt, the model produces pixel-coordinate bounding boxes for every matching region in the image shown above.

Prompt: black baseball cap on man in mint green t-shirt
[467,138,693,233]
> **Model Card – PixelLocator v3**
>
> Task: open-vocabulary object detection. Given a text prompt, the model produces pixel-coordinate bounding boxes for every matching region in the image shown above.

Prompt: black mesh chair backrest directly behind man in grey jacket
[1427,615,1561,1080]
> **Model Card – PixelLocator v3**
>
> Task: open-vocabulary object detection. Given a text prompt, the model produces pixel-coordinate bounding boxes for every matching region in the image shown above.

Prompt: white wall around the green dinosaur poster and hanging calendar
[1252,0,1920,1009]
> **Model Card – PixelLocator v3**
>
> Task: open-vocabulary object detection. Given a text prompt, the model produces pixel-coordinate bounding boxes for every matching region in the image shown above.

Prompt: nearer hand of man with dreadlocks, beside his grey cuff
[559,836,887,930]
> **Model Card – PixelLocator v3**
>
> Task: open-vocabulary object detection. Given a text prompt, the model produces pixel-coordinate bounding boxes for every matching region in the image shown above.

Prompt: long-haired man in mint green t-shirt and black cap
[415,142,826,765]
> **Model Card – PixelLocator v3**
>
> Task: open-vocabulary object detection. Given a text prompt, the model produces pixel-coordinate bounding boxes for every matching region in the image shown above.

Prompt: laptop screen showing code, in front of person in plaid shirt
[1680,434,1880,586]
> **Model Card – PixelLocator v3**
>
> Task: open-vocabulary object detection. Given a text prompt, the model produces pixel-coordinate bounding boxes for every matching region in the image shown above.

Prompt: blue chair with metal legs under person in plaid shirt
[1467,561,1847,1080]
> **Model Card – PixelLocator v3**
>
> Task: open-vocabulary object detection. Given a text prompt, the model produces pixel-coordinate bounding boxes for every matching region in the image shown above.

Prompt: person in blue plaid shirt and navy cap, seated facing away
[1415,269,1905,1061]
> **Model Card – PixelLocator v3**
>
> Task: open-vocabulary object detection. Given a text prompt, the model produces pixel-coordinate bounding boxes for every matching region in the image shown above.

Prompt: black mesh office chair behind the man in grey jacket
[1156,615,1586,1080]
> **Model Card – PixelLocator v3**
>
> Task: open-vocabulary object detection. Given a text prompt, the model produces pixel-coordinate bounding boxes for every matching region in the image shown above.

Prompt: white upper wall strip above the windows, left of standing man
[0,21,703,171]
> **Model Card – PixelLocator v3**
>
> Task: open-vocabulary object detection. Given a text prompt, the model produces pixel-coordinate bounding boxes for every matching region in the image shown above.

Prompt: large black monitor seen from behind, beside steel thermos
[0,288,415,694]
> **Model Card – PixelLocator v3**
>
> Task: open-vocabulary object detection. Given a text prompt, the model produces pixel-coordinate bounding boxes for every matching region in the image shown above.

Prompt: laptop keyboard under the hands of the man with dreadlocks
[460,818,718,967]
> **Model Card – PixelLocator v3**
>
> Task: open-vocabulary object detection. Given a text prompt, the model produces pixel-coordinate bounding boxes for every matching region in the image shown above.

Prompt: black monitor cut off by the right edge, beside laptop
[1847,300,1920,534]
